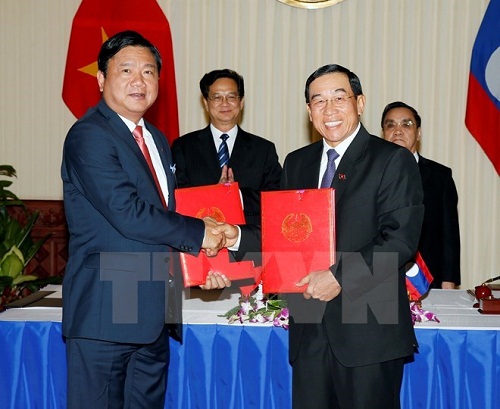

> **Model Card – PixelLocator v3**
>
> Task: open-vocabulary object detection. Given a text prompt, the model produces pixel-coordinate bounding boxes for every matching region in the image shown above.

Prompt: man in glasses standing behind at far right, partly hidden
[381,101,460,289]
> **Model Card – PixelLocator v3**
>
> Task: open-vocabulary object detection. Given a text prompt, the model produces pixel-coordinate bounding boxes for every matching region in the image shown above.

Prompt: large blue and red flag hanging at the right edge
[465,0,500,175]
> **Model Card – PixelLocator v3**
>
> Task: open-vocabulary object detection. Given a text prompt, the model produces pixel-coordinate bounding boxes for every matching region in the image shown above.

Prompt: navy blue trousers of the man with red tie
[66,326,170,409]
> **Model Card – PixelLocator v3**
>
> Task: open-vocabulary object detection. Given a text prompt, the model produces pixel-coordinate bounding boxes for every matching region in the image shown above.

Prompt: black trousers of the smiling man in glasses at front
[292,324,404,409]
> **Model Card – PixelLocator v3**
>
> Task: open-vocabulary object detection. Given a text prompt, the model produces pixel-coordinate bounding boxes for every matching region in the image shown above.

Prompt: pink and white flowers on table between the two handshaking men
[222,286,289,330]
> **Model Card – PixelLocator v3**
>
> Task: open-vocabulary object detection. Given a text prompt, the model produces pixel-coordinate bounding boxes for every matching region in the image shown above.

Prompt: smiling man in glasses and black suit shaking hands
[220,64,423,409]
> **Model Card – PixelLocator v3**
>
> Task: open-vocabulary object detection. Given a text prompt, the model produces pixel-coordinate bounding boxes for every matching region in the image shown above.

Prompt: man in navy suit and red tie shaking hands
[61,31,230,409]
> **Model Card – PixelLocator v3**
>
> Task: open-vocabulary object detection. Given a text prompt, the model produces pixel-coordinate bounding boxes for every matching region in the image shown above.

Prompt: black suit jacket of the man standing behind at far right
[418,156,460,288]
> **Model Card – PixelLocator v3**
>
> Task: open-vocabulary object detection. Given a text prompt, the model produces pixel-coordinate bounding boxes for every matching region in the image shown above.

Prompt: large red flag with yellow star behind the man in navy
[62,0,179,142]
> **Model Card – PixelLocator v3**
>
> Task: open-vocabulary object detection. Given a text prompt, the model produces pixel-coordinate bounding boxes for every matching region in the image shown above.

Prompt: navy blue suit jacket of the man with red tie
[61,100,205,343]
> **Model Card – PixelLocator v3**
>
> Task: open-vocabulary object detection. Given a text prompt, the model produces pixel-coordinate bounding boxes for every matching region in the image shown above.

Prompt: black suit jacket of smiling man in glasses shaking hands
[282,126,423,366]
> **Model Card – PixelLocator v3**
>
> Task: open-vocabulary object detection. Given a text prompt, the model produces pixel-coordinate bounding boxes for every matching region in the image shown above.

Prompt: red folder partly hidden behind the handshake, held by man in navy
[175,182,255,287]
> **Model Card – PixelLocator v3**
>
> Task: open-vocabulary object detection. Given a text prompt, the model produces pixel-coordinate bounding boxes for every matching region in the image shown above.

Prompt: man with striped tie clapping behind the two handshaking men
[172,69,281,225]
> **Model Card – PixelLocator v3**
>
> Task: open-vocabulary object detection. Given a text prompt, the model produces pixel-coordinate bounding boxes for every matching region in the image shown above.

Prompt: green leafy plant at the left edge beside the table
[0,165,50,306]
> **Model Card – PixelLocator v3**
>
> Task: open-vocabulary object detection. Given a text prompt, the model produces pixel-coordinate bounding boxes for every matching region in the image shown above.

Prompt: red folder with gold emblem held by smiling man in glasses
[261,188,335,293]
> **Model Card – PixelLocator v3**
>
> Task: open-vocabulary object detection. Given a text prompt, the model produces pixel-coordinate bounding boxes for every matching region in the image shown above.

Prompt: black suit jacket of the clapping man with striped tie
[172,126,281,225]
